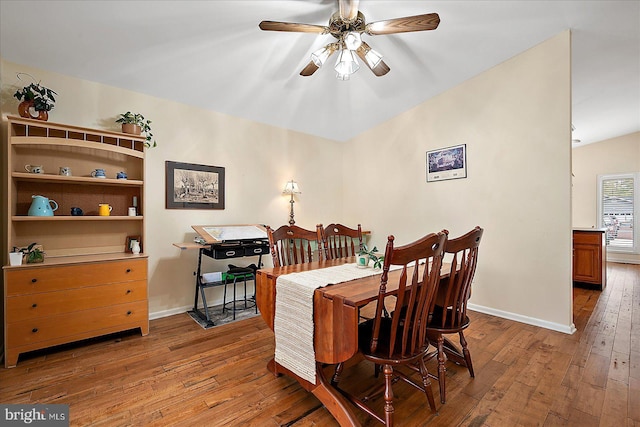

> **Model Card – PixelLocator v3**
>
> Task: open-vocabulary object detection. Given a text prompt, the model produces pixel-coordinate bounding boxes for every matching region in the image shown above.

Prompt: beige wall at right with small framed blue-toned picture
[344,32,572,332]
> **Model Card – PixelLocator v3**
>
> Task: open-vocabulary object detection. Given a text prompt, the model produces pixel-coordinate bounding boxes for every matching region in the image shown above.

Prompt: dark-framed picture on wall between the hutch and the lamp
[165,161,224,209]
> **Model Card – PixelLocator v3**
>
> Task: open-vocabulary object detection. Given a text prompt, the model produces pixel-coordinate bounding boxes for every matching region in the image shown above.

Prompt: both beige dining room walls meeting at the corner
[2,32,572,332]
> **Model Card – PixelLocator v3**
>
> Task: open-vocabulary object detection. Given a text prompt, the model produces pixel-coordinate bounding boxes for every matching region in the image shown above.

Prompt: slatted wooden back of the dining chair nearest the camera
[370,232,447,359]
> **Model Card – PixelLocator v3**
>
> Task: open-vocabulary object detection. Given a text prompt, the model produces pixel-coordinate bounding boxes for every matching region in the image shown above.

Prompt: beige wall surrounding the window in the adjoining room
[572,132,640,264]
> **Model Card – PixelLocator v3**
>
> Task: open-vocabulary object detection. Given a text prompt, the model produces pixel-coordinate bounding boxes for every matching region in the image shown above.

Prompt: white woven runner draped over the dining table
[273,264,382,384]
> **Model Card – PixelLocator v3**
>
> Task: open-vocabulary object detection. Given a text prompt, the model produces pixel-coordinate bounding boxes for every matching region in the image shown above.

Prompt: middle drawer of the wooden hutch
[6,280,147,323]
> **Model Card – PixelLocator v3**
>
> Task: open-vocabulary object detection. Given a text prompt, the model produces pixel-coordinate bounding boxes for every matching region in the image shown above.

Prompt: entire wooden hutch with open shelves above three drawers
[2,116,149,366]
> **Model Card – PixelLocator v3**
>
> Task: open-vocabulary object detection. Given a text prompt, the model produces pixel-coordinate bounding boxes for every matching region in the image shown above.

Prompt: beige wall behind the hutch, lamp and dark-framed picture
[2,61,343,317]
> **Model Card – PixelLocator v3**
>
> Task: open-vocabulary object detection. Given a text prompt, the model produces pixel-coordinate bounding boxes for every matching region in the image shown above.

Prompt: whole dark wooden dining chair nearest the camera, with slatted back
[331,232,447,426]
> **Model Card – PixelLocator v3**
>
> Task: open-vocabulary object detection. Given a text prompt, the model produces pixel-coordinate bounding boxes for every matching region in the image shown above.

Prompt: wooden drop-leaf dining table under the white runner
[256,258,456,426]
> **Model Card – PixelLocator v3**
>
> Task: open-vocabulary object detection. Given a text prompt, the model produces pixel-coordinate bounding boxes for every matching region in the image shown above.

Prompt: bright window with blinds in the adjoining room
[598,173,640,253]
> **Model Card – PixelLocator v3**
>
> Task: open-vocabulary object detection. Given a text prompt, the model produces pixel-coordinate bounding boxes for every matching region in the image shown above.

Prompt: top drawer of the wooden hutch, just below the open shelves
[5,259,147,296]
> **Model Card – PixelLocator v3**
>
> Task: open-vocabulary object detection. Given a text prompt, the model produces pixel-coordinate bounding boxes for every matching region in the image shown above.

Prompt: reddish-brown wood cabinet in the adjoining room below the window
[573,228,607,289]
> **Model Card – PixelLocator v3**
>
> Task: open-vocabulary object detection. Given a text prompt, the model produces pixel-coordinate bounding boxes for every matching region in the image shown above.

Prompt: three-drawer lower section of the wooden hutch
[4,256,149,367]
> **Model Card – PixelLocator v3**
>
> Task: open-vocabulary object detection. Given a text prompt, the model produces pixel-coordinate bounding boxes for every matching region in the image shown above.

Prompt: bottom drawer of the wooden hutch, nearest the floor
[5,301,149,348]
